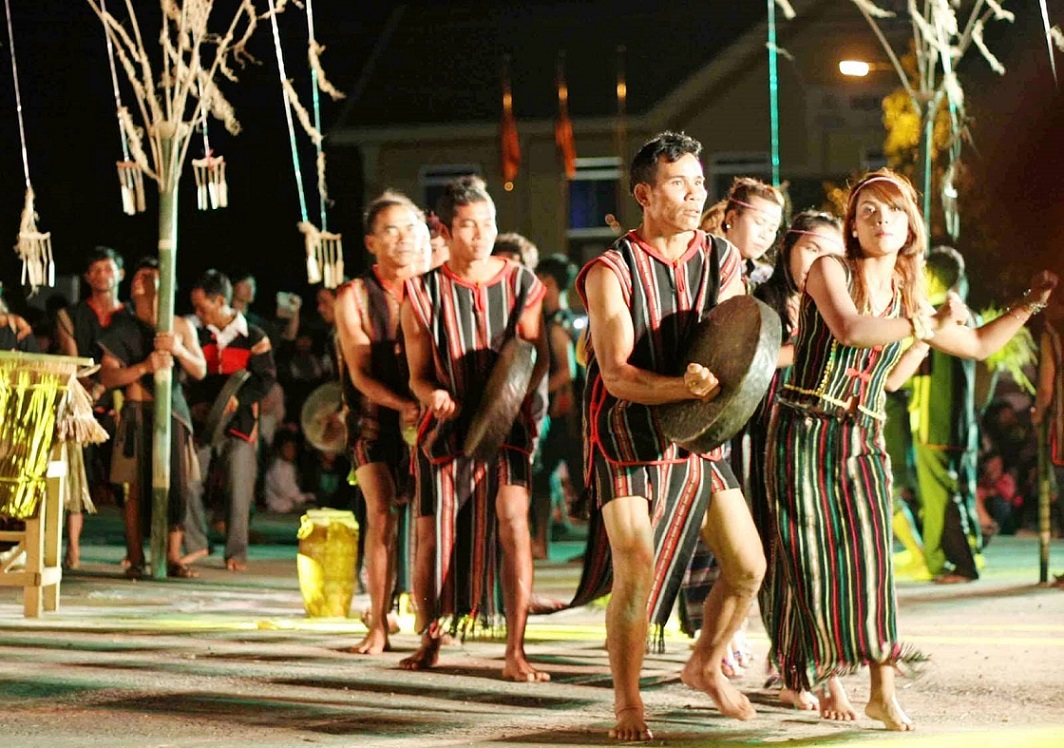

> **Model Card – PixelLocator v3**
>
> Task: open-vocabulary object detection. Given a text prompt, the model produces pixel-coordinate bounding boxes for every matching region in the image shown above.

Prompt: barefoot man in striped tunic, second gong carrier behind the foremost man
[401,178,549,682]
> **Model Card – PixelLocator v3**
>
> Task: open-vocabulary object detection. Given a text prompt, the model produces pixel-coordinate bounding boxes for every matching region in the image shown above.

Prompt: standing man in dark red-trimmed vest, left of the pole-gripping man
[55,247,126,569]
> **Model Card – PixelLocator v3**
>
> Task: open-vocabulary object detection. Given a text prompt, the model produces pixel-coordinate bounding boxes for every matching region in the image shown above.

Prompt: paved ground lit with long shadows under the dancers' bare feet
[0,508,1064,748]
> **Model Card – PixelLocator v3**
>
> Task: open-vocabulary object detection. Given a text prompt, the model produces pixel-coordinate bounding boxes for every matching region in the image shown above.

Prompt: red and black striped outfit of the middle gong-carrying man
[406,261,546,631]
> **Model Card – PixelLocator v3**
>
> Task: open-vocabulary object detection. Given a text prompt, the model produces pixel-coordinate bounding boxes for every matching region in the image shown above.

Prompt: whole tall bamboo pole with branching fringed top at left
[86,0,285,579]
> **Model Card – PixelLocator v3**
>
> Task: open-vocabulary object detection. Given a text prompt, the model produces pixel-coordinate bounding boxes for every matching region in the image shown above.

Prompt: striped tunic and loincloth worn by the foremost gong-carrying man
[572,231,742,644]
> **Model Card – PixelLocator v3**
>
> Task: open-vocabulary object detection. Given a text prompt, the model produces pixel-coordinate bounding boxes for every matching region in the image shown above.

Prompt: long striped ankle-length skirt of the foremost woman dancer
[765,403,925,688]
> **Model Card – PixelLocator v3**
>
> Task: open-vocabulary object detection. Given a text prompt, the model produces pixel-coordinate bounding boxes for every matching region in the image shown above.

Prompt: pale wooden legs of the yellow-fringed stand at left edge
[0,450,67,618]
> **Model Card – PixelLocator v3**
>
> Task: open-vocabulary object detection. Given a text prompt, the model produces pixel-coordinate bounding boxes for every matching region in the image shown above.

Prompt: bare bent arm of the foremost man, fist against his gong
[584,260,697,405]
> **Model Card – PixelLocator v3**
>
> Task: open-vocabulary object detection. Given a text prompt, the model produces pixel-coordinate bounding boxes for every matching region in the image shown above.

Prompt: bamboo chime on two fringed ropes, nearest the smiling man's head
[270,0,344,288]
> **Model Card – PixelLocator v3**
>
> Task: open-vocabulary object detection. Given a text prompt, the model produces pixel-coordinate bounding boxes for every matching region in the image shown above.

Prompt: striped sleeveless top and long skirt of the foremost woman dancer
[765,261,920,688]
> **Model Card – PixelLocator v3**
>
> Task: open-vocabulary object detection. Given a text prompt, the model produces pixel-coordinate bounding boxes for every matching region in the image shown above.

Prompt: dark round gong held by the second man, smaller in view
[462,337,536,462]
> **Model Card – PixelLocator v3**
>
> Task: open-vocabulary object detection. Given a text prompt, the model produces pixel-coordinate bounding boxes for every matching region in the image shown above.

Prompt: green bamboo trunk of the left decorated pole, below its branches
[151,122,181,579]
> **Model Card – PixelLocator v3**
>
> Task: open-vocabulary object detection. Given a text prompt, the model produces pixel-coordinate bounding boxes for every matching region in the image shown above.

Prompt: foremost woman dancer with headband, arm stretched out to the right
[765,169,1057,730]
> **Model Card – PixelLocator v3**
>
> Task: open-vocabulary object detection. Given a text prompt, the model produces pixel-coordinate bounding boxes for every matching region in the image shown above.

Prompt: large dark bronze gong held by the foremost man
[658,296,782,452]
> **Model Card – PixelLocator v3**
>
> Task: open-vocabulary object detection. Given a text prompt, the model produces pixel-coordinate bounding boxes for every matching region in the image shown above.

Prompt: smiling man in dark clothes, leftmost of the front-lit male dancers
[334,193,425,654]
